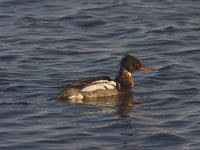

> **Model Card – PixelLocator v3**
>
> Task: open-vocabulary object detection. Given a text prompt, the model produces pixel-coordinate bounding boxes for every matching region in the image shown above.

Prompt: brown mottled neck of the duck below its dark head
[115,68,134,88]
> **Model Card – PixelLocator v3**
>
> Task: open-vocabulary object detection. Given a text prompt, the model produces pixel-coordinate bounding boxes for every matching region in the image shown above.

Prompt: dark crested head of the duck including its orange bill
[120,55,154,73]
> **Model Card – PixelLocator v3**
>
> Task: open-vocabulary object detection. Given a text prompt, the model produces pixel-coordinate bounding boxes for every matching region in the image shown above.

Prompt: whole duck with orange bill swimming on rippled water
[56,54,155,100]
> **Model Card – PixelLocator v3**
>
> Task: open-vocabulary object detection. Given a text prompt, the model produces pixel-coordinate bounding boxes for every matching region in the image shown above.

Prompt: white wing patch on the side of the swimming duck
[81,80,117,92]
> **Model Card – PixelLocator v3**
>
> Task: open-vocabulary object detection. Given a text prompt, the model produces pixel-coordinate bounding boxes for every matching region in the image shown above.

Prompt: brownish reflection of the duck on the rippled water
[60,91,134,117]
